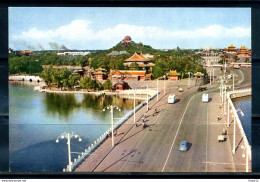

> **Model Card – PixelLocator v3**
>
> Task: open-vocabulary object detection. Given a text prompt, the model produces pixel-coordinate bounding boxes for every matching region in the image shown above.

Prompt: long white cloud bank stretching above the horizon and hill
[11,20,251,49]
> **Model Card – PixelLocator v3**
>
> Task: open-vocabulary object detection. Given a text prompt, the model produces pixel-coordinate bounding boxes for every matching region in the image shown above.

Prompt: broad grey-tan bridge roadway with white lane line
[75,87,234,172]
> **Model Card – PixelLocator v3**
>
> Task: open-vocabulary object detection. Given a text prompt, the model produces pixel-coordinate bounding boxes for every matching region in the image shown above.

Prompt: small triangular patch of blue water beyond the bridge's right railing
[233,96,252,145]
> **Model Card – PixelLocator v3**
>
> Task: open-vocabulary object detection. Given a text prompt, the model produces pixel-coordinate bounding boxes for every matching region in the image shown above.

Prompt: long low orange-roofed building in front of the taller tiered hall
[108,70,151,81]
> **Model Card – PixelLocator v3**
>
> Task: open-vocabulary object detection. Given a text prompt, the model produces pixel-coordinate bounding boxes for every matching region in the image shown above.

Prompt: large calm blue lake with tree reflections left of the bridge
[9,83,140,172]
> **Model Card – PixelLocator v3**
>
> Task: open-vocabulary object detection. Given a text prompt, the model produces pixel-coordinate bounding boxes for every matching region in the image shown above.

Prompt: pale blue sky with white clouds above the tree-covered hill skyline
[9,7,251,50]
